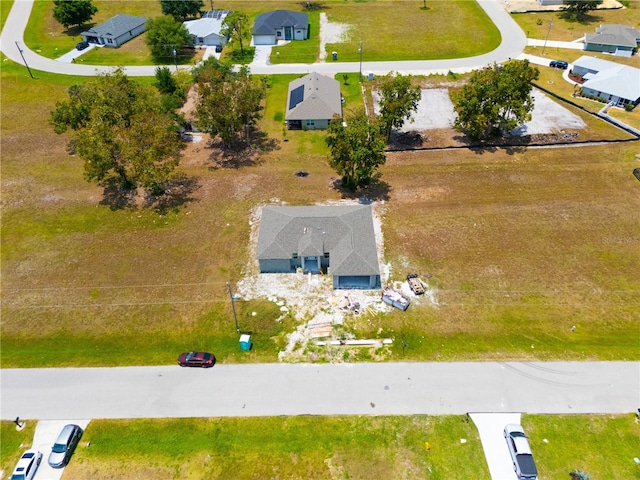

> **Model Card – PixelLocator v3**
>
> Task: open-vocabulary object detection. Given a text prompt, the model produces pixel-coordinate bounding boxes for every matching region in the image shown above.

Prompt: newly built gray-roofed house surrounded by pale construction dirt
[256,205,380,290]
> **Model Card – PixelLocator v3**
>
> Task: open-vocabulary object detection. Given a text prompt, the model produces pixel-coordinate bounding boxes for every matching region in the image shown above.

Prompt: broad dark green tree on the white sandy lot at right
[452,60,540,140]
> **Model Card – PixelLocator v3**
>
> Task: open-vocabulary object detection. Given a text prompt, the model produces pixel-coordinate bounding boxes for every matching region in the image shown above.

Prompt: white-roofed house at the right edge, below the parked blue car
[571,56,640,107]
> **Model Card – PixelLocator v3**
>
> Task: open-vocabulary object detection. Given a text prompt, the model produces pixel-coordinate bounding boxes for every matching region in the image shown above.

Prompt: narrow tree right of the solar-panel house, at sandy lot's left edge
[379,74,422,141]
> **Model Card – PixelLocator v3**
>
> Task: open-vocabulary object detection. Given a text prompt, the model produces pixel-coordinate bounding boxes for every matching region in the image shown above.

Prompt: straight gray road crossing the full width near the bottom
[0,362,640,420]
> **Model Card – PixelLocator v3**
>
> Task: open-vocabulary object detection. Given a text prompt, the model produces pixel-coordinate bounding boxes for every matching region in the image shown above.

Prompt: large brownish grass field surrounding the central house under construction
[1,53,640,367]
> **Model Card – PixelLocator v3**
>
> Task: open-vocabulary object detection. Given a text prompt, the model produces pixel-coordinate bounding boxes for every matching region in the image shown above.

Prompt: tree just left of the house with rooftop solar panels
[196,67,265,147]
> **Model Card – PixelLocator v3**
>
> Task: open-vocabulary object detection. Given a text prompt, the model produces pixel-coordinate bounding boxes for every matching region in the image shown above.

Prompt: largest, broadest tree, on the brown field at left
[50,69,182,193]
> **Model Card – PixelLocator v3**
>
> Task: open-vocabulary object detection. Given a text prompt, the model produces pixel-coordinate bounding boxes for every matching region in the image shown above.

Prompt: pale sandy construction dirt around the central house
[237,198,437,362]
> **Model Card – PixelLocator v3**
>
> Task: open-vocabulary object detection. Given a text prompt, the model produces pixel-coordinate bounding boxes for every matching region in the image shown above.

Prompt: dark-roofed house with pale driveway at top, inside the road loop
[253,10,309,45]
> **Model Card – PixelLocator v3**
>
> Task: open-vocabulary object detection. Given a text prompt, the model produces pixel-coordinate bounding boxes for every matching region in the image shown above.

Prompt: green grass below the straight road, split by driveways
[0,414,640,480]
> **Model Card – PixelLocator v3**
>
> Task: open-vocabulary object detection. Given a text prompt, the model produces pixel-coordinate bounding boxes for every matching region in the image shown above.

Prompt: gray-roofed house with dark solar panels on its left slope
[285,73,342,130]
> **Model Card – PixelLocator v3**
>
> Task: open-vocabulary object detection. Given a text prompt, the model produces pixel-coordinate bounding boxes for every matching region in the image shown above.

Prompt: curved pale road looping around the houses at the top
[0,0,527,76]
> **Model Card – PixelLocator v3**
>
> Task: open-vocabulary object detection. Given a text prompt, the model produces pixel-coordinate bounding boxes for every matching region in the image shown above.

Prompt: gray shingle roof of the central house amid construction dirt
[256,205,380,276]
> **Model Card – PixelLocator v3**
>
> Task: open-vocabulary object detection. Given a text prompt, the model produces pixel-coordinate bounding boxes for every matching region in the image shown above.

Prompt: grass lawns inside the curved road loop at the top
[25,0,500,65]
